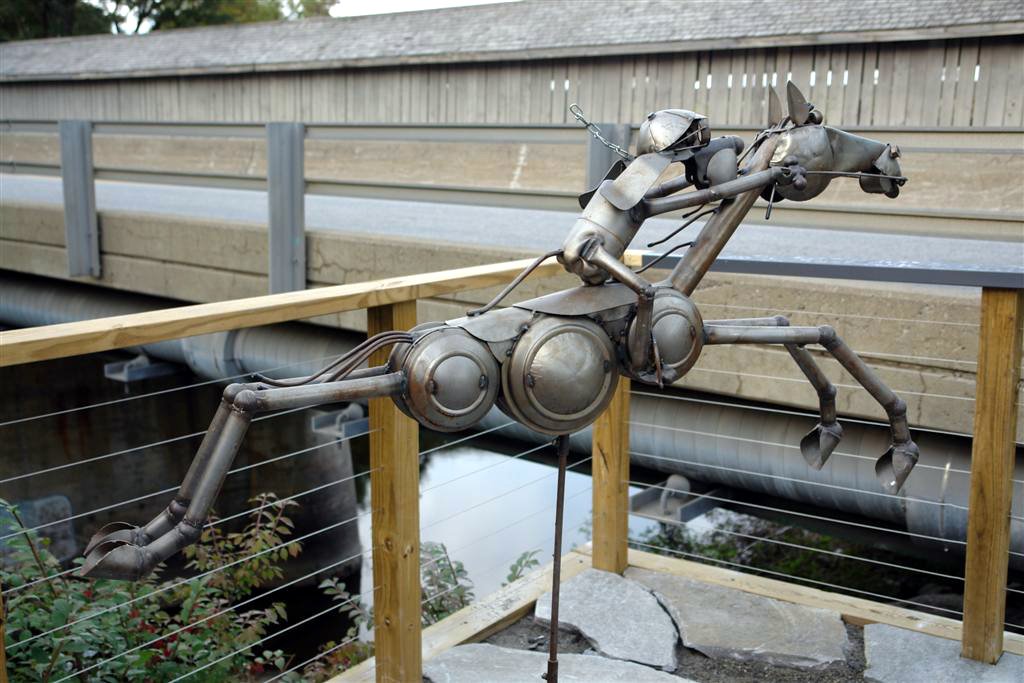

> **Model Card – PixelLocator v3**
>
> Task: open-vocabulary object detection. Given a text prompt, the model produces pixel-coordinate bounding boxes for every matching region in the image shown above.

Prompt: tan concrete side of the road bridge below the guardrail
[0,205,1011,439]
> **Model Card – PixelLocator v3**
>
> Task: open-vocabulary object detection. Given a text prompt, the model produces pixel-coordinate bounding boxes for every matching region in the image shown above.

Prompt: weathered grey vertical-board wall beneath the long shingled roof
[0,36,1024,127]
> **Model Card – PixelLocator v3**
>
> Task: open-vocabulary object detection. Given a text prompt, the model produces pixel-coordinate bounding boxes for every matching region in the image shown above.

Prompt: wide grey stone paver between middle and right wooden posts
[626,567,848,669]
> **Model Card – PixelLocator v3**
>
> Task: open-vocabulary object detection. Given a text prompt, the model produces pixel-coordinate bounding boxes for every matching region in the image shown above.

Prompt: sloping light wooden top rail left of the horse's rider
[0,259,561,367]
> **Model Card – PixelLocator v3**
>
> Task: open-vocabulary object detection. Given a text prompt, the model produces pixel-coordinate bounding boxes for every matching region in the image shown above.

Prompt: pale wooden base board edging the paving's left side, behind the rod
[328,552,590,683]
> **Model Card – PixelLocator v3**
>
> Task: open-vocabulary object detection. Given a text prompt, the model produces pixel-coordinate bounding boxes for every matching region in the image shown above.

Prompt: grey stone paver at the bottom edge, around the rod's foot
[423,643,693,683]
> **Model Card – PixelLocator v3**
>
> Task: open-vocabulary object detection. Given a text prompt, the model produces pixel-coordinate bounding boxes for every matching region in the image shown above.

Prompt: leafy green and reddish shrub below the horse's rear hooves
[0,494,301,682]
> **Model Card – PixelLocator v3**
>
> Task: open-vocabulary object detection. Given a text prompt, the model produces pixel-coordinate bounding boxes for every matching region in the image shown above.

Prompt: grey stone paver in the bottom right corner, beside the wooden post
[864,624,1024,683]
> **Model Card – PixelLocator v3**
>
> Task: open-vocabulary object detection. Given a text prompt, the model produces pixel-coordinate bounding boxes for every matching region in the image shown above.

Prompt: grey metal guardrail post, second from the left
[266,123,306,294]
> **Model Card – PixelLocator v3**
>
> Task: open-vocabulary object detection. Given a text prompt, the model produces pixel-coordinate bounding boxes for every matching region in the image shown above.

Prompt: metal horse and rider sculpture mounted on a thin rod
[82,83,918,681]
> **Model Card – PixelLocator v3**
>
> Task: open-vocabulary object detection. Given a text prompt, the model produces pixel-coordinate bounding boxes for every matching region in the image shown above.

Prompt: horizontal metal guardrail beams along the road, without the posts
[0,120,1024,240]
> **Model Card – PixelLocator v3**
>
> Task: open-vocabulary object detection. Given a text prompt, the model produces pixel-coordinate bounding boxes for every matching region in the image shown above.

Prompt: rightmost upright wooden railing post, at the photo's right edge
[962,289,1024,664]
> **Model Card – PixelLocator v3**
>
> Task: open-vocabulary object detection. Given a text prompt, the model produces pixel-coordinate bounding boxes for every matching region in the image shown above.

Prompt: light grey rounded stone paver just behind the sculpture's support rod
[534,569,679,671]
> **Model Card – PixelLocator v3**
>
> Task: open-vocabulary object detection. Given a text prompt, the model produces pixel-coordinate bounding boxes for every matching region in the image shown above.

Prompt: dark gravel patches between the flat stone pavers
[484,614,865,683]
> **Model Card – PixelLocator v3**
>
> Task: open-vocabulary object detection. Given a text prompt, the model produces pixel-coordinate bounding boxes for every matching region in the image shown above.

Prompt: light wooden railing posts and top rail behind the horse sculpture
[0,253,1024,681]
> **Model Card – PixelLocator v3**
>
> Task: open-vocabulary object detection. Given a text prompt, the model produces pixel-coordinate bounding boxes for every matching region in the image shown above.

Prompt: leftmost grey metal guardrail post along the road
[58,121,102,278]
